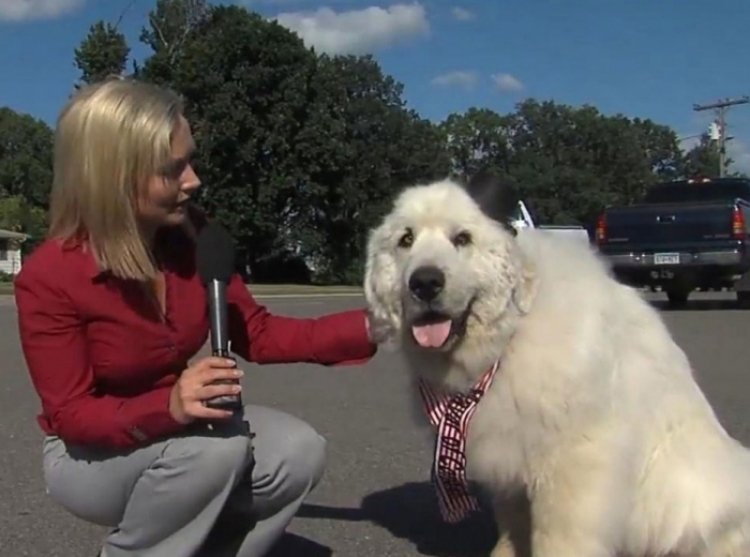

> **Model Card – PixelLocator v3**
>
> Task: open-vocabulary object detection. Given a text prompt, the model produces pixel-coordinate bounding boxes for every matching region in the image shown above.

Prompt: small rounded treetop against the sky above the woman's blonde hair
[74,21,130,83]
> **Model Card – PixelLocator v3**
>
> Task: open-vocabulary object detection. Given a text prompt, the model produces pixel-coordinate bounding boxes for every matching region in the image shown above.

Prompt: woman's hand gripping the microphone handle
[169,357,242,424]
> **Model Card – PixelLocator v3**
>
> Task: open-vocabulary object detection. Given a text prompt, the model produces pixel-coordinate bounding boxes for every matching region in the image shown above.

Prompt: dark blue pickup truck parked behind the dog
[595,178,750,306]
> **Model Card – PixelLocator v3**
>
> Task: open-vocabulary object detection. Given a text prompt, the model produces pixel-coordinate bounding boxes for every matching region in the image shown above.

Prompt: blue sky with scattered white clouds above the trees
[0,0,750,170]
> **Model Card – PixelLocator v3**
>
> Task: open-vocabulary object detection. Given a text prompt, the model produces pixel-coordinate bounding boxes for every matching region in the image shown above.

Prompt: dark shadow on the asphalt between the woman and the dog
[298,482,497,557]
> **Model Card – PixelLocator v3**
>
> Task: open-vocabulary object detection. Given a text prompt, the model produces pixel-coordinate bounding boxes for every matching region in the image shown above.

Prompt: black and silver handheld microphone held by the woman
[195,222,242,410]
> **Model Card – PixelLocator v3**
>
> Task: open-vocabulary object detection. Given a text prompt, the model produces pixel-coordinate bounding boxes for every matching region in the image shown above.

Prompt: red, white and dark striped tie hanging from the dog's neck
[419,362,499,523]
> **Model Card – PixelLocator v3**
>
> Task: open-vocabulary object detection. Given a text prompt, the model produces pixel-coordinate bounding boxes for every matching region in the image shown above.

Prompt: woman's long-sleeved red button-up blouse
[15,222,376,448]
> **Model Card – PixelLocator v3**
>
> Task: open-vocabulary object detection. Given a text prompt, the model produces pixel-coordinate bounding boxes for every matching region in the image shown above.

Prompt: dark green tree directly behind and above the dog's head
[299,56,449,283]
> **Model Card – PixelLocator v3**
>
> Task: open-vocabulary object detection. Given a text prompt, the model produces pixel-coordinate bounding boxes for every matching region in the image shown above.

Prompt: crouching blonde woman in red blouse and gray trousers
[15,79,375,557]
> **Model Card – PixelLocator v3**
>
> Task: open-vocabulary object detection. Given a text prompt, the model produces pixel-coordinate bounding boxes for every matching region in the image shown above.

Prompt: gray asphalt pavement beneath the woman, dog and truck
[0,294,750,557]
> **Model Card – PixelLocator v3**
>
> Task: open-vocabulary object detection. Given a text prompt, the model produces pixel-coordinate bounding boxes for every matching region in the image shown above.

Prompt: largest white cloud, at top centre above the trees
[275,3,430,54]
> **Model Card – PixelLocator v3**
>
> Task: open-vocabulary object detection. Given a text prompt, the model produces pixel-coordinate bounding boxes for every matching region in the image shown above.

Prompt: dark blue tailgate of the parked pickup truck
[606,202,734,248]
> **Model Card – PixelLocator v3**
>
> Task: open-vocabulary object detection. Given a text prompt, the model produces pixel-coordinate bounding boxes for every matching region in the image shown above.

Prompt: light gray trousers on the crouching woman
[44,406,325,557]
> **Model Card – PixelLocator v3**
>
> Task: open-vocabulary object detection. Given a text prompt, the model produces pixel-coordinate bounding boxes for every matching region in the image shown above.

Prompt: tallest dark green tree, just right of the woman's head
[150,6,315,274]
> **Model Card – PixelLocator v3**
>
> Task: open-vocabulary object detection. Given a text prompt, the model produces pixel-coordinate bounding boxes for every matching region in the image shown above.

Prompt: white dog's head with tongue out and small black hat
[364,167,535,352]
